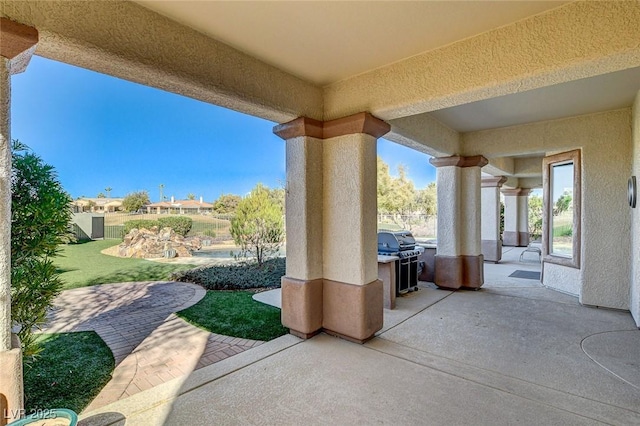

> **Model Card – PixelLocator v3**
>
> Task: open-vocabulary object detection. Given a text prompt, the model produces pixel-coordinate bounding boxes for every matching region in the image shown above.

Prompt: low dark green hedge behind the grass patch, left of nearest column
[171,257,286,290]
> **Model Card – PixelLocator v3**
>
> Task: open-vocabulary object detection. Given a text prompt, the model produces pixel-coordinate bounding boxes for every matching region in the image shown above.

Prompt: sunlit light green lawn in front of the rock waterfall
[54,240,193,290]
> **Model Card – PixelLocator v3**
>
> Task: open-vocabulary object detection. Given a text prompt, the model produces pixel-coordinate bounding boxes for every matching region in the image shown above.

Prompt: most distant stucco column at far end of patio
[502,188,531,247]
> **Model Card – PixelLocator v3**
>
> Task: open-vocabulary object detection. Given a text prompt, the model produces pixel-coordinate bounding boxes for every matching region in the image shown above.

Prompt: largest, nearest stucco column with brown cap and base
[274,113,389,342]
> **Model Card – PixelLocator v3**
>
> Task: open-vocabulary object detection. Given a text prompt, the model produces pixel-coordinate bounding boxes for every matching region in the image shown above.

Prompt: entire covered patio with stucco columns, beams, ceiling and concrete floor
[0,0,640,424]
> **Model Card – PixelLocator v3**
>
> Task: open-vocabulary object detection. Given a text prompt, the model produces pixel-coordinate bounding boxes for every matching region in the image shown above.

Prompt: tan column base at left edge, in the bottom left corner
[0,335,24,426]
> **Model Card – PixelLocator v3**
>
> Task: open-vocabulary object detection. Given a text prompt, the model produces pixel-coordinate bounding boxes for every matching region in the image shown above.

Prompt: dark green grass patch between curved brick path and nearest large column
[177,291,288,340]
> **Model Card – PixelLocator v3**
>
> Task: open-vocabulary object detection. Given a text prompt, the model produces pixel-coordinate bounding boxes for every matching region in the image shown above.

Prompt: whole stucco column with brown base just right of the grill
[429,155,487,289]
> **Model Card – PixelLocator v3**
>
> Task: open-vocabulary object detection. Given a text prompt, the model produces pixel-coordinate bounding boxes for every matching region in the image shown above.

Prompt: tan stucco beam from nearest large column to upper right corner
[324,1,640,120]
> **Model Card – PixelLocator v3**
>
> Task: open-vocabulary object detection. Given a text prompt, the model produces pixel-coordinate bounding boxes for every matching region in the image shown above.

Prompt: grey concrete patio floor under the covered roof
[80,249,640,425]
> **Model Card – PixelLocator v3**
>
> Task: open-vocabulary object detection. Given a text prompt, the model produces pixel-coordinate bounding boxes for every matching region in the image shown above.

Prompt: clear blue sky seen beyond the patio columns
[11,56,435,201]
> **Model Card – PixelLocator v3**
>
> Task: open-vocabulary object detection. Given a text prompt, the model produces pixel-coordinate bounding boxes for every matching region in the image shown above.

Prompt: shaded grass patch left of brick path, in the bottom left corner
[24,331,115,413]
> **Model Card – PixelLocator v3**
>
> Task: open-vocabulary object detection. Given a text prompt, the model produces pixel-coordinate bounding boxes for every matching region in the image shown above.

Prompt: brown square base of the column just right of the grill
[434,254,484,290]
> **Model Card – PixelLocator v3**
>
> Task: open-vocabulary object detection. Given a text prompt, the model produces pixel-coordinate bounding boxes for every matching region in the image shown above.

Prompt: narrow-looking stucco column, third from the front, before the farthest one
[481,176,507,263]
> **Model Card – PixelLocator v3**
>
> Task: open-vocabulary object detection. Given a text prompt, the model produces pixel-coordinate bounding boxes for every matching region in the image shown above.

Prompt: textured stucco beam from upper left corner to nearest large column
[0,0,323,123]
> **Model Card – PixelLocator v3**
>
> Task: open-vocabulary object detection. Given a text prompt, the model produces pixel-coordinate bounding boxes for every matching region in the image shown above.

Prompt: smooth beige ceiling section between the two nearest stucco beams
[136,0,567,86]
